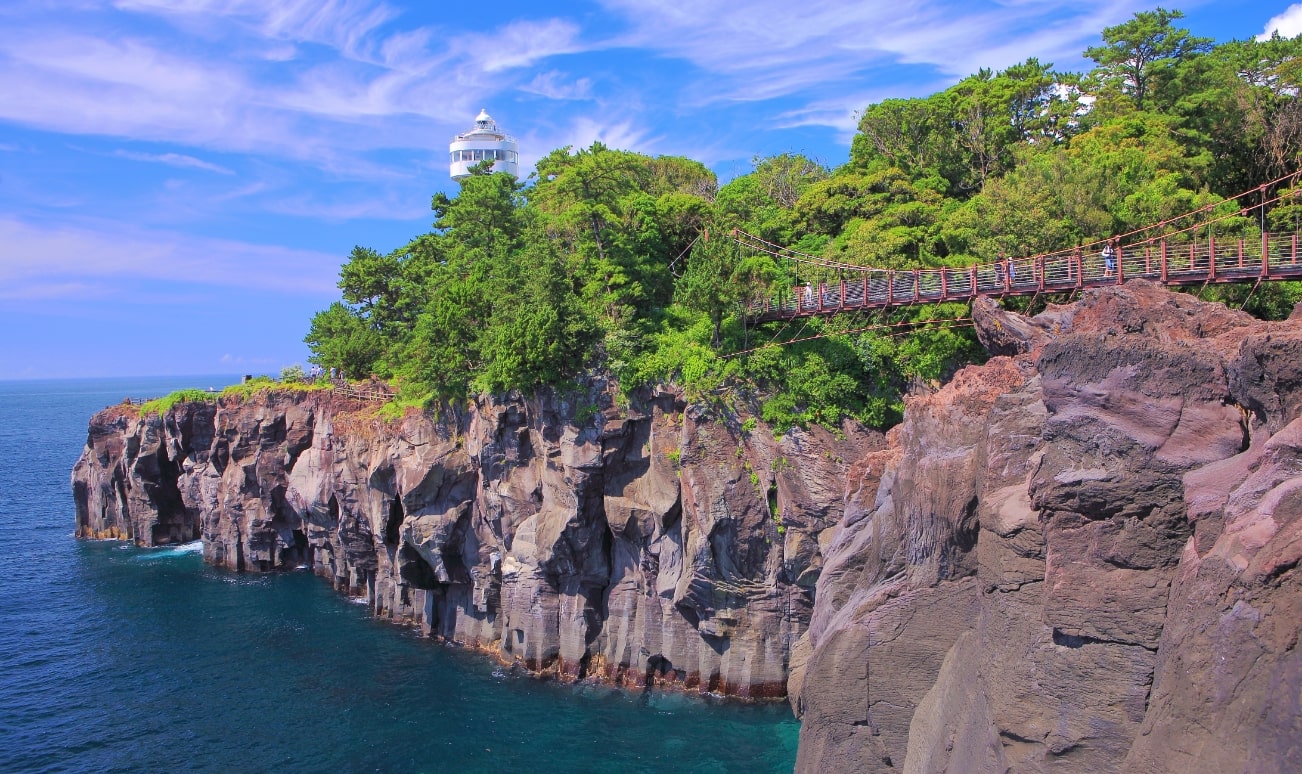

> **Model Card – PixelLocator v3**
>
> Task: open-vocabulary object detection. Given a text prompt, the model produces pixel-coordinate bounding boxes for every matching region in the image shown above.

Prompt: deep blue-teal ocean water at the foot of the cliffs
[0,377,798,774]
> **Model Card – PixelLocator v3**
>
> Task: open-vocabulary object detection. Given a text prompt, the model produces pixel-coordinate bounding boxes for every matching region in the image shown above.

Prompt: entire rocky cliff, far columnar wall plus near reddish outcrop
[73,281,1302,773]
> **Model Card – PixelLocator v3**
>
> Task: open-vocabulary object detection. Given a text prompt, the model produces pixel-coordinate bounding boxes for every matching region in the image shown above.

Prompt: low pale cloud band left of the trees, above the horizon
[0,218,340,301]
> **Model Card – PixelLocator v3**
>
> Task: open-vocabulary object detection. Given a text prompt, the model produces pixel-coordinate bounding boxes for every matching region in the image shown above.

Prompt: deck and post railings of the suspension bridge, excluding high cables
[730,231,1302,321]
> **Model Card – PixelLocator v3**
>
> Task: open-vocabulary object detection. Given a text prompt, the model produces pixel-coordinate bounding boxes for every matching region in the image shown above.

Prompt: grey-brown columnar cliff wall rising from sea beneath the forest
[73,384,881,697]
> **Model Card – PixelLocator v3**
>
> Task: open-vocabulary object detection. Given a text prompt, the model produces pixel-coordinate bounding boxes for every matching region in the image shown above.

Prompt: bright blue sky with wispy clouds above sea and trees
[0,0,1302,379]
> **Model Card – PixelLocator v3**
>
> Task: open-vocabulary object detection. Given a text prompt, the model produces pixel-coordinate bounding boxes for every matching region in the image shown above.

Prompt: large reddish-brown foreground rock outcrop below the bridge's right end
[792,283,1302,773]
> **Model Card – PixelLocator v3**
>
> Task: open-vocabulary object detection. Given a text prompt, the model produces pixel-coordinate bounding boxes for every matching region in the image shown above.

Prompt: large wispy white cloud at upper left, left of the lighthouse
[0,0,590,164]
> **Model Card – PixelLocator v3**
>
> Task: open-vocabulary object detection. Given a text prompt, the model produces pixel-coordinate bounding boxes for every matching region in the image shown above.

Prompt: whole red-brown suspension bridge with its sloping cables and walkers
[729,173,1302,322]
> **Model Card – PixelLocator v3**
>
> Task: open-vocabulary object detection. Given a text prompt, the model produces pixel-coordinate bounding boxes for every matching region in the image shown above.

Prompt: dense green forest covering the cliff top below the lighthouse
[306,8,1302,427]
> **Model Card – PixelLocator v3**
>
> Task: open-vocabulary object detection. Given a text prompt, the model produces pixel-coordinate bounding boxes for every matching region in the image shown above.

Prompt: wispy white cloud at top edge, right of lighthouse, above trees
[600,0,1141,132]
